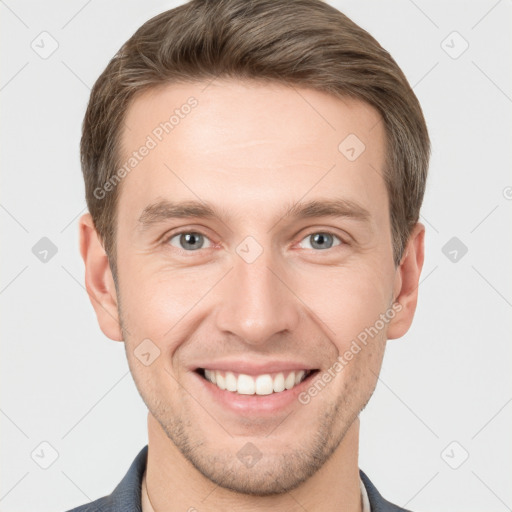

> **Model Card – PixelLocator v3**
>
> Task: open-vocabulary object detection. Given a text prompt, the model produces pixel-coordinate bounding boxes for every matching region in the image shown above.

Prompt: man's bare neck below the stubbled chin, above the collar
[145,413,362,512]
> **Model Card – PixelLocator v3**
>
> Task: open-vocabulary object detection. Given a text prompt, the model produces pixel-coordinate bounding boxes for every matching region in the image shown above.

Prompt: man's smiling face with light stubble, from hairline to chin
[110,81,398,495]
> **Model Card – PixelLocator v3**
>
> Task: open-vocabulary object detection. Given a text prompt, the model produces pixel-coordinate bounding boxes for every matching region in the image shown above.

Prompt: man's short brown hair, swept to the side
[80,0,430,282]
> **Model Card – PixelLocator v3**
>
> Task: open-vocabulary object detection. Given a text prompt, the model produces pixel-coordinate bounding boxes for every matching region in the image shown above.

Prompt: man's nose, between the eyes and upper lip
[216,246,301,345]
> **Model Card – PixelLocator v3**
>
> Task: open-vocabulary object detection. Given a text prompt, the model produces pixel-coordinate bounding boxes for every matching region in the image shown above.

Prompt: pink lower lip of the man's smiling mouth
[192,371,319,415]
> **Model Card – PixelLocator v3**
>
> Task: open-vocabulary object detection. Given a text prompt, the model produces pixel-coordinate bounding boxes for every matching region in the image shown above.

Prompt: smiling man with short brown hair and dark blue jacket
[69,0,430,512]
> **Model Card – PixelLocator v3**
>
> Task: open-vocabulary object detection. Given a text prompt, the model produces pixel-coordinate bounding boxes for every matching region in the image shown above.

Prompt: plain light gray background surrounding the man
[0,0,512,512]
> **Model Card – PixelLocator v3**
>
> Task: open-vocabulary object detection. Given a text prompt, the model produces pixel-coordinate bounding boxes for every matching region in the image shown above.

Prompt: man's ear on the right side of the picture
[387,222,425,339]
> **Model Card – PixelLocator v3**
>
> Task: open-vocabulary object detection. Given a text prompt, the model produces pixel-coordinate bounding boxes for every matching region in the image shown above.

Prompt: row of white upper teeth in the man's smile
[204,369,306,395]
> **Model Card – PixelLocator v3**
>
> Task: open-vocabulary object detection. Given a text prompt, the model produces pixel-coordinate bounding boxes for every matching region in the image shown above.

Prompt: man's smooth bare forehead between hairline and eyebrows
[119,80,387,224]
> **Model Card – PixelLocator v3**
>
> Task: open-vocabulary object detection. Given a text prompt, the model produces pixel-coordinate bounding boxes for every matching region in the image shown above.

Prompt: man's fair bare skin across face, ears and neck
[80,80,424,512]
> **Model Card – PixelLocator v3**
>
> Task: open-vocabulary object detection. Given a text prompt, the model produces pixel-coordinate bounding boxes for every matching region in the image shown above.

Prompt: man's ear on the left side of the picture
[79,213,123,341]
